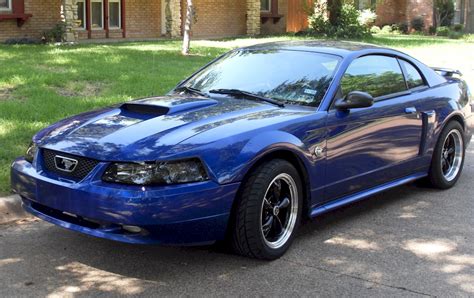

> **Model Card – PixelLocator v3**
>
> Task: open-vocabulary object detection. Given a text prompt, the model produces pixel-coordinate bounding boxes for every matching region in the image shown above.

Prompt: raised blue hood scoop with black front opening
[120,98,217,117]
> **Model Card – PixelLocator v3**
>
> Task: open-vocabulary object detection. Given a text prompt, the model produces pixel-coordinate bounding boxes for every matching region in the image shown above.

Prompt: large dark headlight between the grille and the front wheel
[102,158,209,185]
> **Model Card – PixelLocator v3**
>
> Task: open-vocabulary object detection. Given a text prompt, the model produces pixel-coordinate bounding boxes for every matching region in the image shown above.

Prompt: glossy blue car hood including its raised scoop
[34,96,308,161]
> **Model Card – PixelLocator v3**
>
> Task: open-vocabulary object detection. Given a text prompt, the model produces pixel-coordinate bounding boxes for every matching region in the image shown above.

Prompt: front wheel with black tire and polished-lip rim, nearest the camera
[231,159,303,260]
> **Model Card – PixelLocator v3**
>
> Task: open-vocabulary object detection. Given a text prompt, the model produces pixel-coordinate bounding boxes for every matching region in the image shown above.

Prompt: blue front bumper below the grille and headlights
[11,158,240,245]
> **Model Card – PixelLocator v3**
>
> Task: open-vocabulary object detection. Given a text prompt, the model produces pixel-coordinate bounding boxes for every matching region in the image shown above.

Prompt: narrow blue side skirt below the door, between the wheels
[310,173,428,217]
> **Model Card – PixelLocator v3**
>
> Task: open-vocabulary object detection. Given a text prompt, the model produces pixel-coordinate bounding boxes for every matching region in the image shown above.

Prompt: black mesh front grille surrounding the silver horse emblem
[43,149,99,179]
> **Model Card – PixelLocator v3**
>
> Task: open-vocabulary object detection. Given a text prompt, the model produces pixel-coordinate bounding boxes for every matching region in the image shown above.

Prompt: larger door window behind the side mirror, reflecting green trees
[341,55,406,98]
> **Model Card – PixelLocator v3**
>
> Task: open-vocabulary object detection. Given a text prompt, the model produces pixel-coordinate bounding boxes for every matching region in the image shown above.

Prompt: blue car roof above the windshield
[241,40,395,57]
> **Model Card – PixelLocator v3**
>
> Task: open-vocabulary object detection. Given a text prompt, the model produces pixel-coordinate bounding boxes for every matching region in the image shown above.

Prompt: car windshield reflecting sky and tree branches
[181,50,340,106]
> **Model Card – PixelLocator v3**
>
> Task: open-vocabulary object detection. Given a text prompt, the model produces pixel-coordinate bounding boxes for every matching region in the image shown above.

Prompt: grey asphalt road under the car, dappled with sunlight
[0,146,474,297]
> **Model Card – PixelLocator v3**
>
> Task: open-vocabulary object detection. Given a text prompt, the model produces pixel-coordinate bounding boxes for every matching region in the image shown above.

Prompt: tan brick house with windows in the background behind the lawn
[0,0,474,41]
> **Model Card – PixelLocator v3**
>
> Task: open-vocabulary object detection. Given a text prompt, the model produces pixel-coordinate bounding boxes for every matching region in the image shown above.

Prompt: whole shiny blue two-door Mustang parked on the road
[11,41,473,260]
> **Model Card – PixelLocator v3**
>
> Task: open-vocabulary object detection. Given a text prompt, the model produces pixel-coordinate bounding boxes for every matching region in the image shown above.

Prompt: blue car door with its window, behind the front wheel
[325,55,422,201]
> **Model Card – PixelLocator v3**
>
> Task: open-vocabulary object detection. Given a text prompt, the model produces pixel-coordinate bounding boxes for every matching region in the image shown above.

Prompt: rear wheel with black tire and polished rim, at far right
[428,121,466,189]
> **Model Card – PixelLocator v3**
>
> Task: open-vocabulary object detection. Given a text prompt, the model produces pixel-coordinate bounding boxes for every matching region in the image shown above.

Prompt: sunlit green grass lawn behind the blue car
[0,35,474,194]
